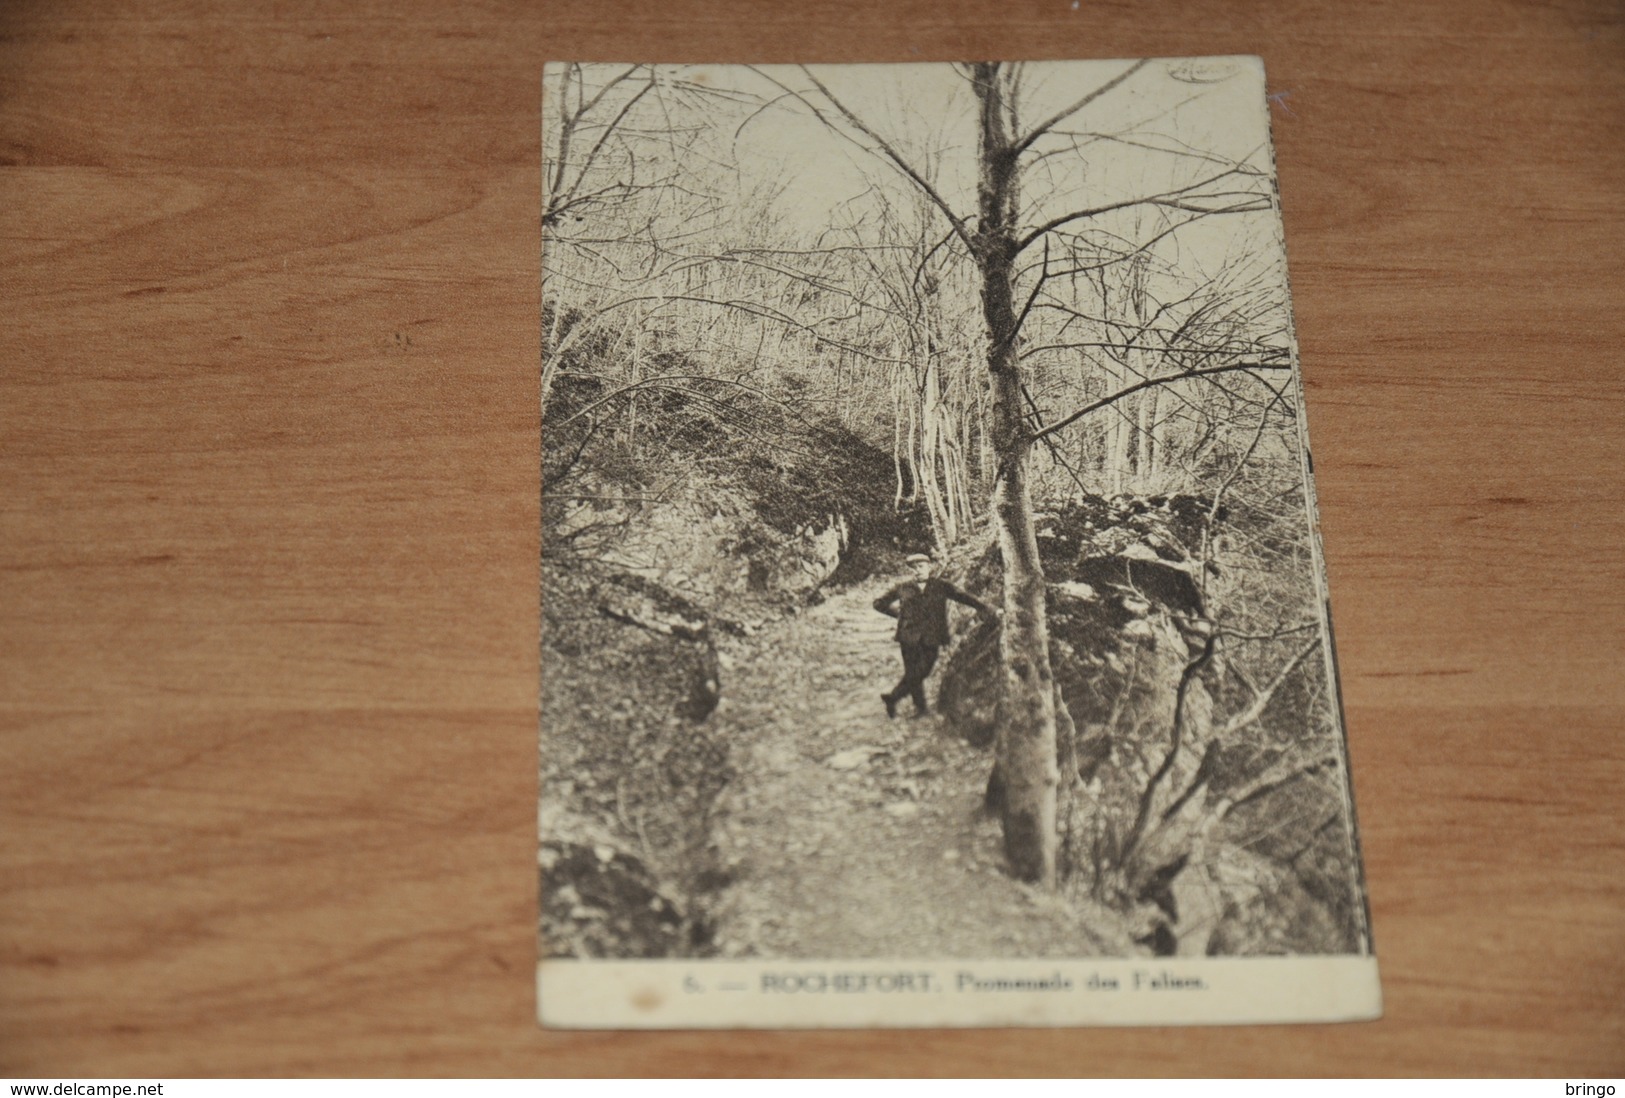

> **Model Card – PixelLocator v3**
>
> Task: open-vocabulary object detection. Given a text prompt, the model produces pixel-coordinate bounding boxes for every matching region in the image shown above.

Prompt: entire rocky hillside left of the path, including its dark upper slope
[541,339,930,957]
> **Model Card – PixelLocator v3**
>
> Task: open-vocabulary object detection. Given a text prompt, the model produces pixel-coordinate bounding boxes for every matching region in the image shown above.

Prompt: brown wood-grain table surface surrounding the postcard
[0,0,1625,1079]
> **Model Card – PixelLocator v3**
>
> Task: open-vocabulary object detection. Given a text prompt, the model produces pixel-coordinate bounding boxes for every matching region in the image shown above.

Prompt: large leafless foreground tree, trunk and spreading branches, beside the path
[772,62,1289,887]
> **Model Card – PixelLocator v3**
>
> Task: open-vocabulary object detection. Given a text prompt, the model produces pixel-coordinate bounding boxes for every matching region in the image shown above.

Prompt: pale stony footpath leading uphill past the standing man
[713,580,1105,958]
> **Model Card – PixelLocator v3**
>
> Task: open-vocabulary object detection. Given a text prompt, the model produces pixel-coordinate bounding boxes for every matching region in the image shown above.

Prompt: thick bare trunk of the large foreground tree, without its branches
[975,62,1060,888]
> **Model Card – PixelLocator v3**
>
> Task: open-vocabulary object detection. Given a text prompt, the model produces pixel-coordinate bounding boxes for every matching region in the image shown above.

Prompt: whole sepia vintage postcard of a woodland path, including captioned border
[538,57,1381,1028]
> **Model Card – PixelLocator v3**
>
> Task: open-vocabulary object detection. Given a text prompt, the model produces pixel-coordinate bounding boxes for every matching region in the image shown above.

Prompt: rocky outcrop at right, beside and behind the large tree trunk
[939,497,1352,955]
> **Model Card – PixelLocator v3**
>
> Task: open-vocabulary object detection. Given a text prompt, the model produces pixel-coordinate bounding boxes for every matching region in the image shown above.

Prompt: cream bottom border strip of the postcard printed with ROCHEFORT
[536,955,1383,1030]
